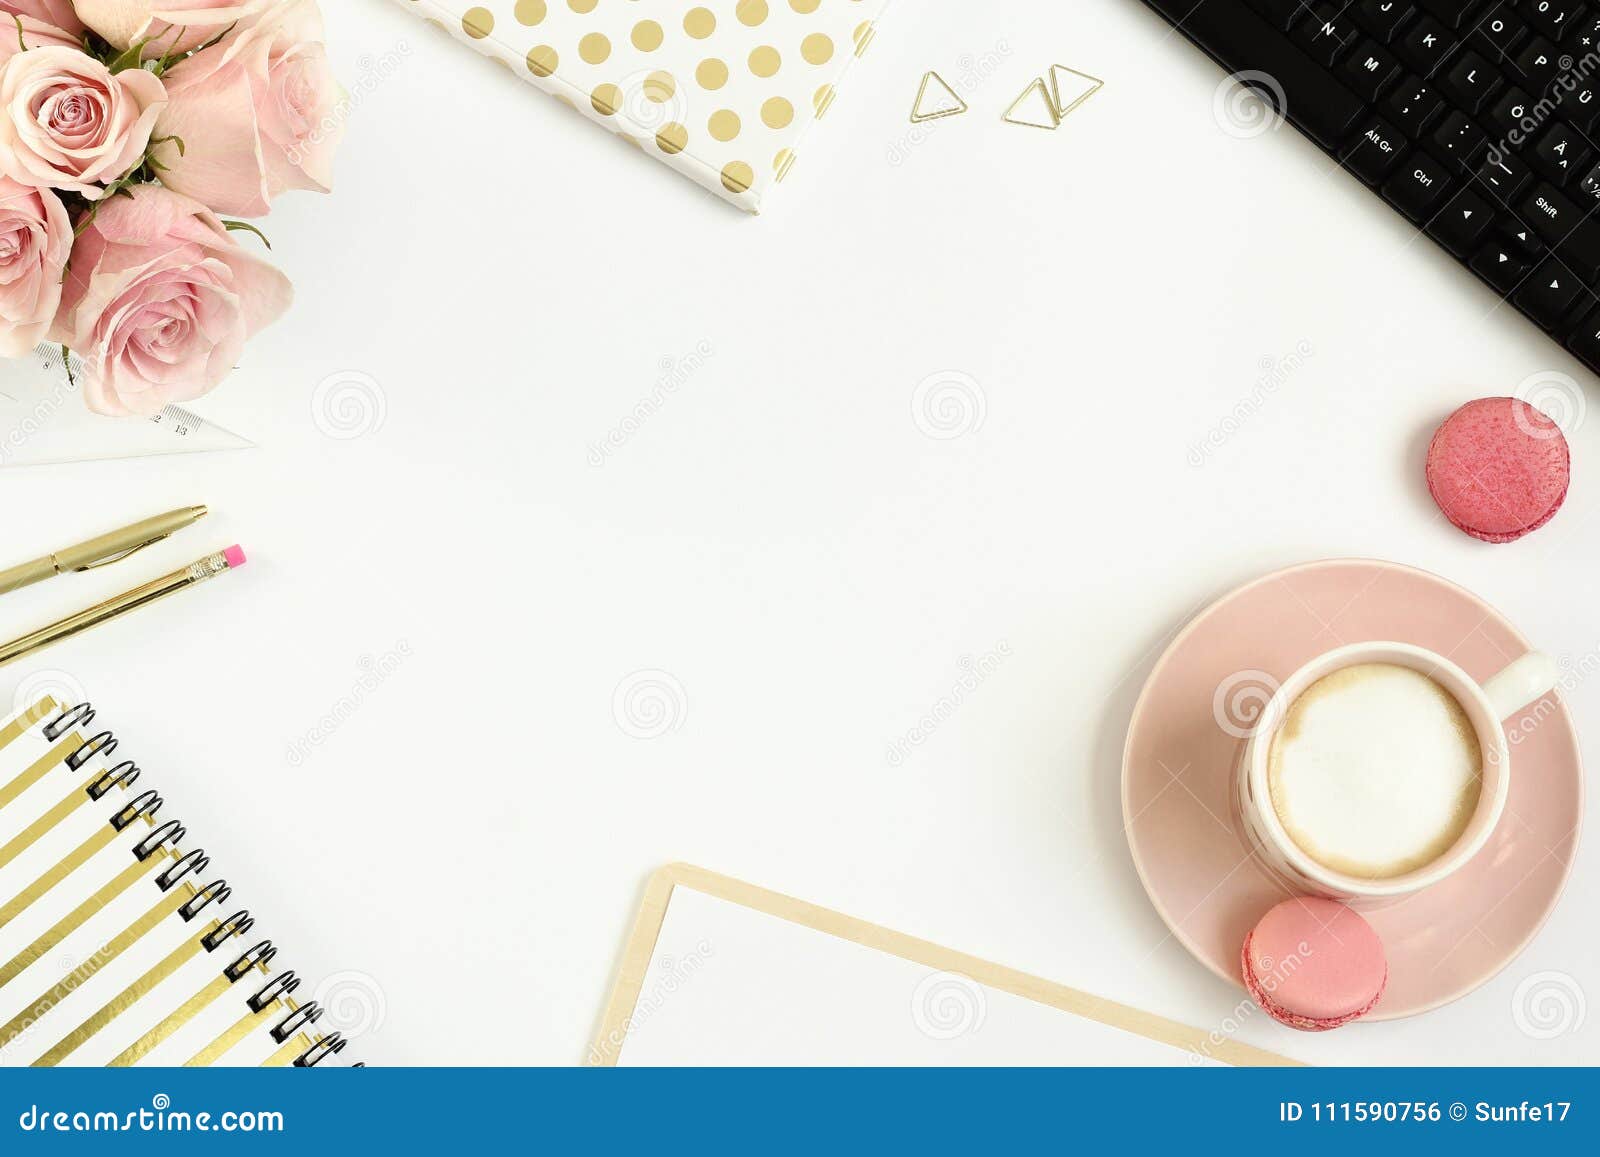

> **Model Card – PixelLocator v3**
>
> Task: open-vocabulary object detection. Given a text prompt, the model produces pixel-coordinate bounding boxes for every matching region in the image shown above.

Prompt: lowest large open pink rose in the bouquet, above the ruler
[50,184,293,414]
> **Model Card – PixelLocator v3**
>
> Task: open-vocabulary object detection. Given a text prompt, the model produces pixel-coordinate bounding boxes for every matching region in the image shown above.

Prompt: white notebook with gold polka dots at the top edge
[400,0,888,213]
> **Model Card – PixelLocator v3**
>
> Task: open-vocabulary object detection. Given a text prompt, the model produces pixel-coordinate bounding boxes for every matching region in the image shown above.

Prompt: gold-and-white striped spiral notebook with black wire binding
[0,696,349,1067]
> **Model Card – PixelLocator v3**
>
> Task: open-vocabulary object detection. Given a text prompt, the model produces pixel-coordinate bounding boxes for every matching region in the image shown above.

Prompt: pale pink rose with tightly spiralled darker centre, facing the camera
[0,46,166,200]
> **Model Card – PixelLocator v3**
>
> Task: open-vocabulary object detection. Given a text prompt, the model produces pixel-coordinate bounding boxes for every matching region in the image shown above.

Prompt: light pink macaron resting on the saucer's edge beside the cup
[1242,896,1389,1032]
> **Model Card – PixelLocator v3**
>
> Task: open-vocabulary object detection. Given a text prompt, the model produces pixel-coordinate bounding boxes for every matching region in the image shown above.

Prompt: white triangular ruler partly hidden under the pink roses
[0,346,254,467]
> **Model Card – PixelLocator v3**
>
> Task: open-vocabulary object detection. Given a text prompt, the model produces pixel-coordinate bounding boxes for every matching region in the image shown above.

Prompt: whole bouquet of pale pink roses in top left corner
[0,0,341,414]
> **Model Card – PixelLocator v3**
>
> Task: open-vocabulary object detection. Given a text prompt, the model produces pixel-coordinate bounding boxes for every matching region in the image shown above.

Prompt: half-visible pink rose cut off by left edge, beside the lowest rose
[0,178,72,357]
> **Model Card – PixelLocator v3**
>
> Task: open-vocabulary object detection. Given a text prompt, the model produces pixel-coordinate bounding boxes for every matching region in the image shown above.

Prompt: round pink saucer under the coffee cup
[1122,558,1584,1021]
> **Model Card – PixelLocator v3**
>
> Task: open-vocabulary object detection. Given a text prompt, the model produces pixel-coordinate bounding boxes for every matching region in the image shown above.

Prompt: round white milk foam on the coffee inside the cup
[1267,663,1483,879]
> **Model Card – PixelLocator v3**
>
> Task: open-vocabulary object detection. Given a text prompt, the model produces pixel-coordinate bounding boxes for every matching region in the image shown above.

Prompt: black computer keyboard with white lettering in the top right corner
[1144,0,1600,373]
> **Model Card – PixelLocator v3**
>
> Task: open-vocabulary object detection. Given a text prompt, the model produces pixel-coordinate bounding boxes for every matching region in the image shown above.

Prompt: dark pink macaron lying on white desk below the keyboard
[1427,398,1571,542]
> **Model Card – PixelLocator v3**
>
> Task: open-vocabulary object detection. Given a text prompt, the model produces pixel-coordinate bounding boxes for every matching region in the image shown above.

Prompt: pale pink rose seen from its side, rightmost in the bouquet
[155,0,341,216]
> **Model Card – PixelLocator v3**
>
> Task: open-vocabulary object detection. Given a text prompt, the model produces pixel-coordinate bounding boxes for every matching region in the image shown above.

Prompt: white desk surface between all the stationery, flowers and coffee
[0,0,1600,1064]
